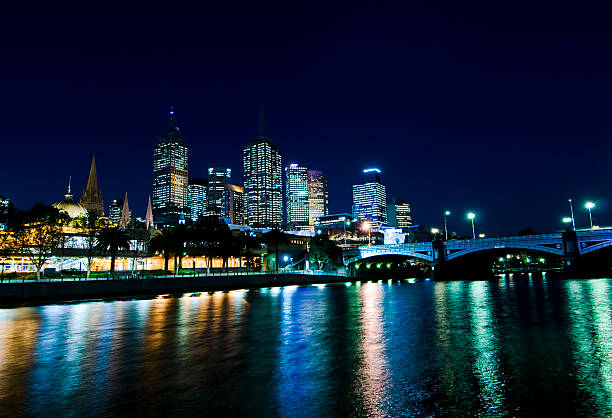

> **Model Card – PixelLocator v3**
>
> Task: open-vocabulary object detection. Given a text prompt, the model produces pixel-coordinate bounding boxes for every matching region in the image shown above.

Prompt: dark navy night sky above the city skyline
[0,2,612,235]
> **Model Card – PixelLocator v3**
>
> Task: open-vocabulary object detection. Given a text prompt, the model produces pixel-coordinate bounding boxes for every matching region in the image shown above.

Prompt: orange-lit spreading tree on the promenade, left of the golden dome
[16,203,67,280]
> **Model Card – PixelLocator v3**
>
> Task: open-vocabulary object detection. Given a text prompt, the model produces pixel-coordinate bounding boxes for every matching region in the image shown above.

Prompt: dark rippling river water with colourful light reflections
[0,277,612,416]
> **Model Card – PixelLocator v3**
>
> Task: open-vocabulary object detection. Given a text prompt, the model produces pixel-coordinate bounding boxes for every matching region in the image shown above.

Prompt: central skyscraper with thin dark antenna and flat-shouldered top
[242,108,283,228]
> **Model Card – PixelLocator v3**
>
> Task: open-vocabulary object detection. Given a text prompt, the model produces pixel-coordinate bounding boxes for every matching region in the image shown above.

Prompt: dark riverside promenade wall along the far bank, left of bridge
[0,271,353,306]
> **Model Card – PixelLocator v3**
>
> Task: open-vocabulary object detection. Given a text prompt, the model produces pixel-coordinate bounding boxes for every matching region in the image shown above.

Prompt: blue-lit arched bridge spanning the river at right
[343,229,612,266]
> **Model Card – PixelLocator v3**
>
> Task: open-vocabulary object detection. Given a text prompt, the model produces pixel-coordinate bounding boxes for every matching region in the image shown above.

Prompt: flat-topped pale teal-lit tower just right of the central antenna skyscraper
[285,163,308,231]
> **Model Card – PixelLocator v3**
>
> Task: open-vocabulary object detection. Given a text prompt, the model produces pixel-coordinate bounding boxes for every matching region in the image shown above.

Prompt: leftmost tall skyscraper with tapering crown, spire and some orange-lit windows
[153,107,189,226]
